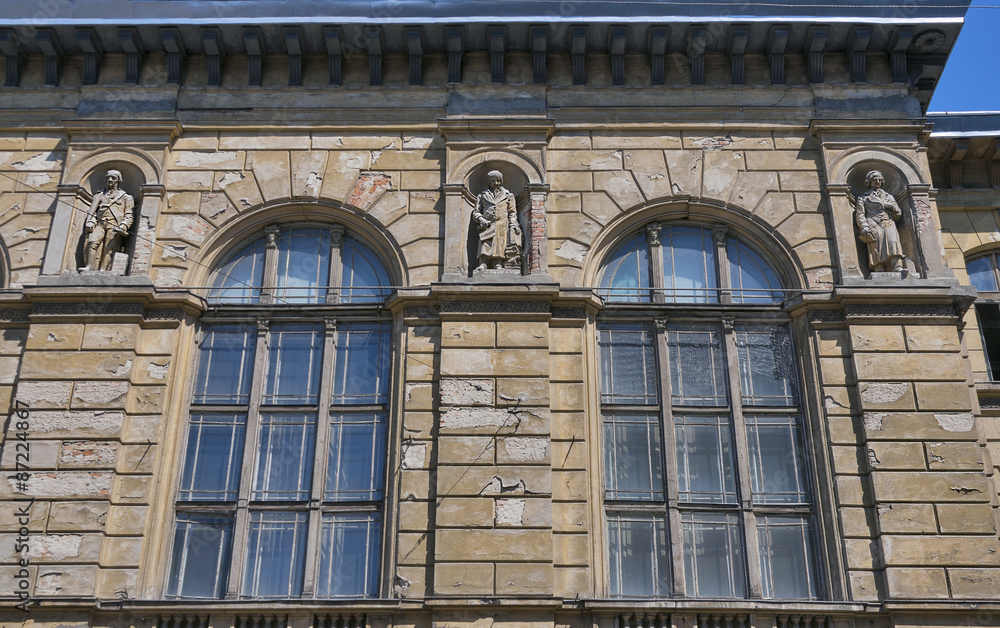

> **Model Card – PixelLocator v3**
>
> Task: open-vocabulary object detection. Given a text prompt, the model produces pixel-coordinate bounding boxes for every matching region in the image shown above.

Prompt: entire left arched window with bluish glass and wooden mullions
[165,225,391,599]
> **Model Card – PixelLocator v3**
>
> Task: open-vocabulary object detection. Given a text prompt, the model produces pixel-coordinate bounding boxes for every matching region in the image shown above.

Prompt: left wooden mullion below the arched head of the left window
[226,320,269,598]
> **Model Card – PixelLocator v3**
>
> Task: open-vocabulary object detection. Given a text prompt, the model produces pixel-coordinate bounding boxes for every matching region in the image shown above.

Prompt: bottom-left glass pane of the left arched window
[167,513,233,599]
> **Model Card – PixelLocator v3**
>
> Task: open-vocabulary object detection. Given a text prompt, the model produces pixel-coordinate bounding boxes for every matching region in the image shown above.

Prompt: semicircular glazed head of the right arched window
[599,223,783,304]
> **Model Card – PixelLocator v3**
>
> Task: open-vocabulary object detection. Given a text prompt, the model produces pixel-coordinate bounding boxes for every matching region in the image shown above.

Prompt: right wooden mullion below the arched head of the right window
[722,318,763,598]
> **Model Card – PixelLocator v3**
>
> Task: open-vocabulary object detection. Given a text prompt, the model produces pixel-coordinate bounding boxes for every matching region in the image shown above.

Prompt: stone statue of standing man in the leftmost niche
[81,170,135,270]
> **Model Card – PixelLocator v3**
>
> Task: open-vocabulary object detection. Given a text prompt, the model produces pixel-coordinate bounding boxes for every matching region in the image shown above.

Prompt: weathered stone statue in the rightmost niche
[854,170,903,272]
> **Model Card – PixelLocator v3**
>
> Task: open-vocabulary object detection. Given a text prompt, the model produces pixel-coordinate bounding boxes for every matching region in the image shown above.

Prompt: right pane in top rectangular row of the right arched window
[736,325,799,406]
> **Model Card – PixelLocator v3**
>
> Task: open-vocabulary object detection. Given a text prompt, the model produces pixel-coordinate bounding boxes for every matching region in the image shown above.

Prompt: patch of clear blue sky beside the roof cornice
[928,0,1000,111]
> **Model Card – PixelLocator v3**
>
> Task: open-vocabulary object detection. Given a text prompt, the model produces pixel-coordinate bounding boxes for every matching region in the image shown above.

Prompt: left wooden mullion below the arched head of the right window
[656,316,685,597]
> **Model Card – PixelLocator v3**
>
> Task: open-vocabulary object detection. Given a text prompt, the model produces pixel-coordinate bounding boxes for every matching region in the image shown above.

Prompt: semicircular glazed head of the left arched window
[208,225,391,305]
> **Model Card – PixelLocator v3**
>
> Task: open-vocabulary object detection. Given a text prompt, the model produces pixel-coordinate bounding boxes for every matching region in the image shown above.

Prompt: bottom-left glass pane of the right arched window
[608,512,670,597]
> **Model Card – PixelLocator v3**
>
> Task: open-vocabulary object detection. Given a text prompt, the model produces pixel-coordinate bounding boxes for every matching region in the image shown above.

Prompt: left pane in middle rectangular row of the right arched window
[604,412,663,501]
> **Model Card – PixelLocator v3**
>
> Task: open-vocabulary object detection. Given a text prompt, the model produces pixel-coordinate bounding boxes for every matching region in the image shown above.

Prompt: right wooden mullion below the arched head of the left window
[302,318,337,597]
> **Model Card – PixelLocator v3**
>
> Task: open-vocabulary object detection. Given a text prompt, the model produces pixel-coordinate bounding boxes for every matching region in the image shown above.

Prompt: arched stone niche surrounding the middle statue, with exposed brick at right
[444,147,550,282]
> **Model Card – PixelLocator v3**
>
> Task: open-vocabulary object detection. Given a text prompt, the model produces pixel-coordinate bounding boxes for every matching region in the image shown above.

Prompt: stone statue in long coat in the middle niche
[472,170,524,270]
